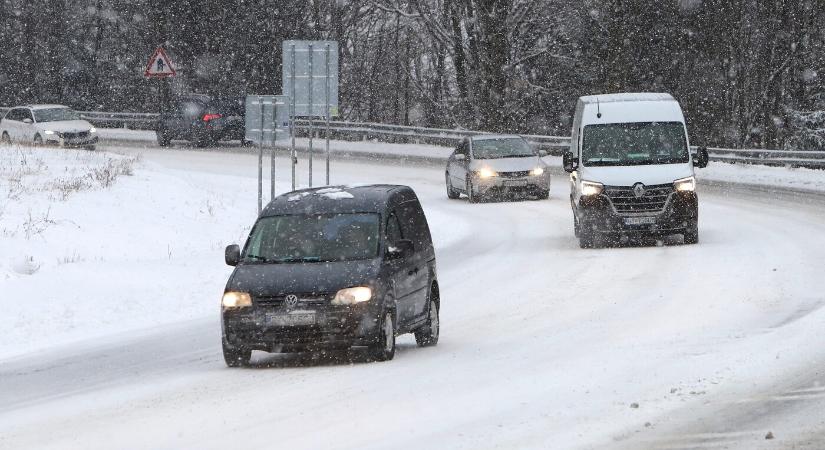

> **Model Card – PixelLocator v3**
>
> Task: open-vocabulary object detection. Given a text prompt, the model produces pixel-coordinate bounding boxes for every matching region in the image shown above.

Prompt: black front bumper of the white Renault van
[577,192,699,236]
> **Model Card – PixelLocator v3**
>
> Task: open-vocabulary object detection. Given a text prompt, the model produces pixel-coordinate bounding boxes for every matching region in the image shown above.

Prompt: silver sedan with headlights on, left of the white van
[445,135,550,203]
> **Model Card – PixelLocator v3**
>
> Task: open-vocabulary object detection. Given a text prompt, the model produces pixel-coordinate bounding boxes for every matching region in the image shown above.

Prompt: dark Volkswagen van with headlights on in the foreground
[221,185,440,367]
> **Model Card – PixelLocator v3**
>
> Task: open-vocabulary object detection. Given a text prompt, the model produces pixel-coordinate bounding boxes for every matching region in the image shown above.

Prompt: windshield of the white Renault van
[582,122,689,166]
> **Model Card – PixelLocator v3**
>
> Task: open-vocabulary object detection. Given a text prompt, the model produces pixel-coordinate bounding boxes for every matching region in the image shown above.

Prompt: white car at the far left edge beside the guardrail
[0,105,97,150]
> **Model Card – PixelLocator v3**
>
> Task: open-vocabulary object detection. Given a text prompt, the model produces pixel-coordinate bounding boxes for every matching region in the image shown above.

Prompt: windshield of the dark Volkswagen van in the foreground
[238,213,380,264]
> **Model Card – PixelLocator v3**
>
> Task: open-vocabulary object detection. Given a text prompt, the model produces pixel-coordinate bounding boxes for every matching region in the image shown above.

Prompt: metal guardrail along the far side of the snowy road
[0,107,825,169]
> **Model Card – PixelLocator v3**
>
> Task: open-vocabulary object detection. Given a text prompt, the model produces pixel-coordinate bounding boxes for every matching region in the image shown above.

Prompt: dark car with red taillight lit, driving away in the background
[156,95,246,147]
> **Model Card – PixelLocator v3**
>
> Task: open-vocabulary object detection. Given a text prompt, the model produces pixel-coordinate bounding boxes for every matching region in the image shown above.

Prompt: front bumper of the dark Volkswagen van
[221,302,380,352]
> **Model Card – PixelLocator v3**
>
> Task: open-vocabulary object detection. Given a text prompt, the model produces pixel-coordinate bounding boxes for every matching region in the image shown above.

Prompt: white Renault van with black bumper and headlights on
[564,93,708,248]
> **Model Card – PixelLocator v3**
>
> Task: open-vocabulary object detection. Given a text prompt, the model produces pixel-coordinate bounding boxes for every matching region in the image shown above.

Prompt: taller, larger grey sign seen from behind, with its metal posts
[282,41,338,189]
